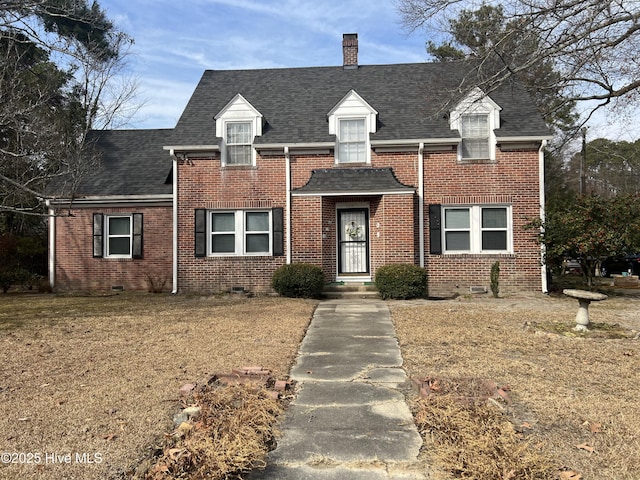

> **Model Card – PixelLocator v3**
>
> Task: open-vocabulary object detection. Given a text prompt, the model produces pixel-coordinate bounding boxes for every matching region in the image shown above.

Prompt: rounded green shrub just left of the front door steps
[271,263,324,298]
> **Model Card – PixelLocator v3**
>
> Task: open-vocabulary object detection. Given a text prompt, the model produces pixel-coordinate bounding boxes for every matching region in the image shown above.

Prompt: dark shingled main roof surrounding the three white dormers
[170,62,549,147]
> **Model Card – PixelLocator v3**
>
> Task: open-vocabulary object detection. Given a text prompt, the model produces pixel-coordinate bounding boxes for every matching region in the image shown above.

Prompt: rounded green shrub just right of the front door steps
[375,263,427,300]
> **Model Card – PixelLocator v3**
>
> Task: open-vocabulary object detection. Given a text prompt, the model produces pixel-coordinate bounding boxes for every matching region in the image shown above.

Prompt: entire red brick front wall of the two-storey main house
[172,145,541,295]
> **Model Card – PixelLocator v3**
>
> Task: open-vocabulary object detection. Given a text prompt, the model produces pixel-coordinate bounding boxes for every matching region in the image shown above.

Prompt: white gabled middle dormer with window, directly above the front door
[327,90,378,164]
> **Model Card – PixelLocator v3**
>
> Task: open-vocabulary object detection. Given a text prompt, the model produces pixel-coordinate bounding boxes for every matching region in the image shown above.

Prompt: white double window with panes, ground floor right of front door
[443,205,512,253]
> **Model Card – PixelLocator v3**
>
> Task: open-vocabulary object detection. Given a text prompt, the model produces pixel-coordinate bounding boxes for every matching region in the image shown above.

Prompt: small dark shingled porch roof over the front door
[293,168,415,195]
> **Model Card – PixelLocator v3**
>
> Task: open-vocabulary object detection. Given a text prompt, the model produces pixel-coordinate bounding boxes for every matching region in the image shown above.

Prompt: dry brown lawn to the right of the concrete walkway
[392,295,640,480]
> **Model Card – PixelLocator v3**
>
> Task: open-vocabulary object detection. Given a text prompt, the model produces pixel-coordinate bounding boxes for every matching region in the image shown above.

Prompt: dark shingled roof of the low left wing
[76,129,173,196]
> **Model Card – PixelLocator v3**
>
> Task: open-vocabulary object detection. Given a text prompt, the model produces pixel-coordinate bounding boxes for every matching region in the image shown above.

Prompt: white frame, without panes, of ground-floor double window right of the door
[442,204,513,255]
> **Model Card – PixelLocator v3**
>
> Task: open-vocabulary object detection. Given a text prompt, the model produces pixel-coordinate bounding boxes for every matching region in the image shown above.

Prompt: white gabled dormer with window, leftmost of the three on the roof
[215,94,263,166]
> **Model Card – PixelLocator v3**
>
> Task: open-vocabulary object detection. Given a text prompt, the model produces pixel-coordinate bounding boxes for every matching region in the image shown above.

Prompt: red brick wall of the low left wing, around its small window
[55,207,172,291]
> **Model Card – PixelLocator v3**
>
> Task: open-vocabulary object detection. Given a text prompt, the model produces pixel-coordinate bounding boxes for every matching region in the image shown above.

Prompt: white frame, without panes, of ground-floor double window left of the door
[207,209,273,257]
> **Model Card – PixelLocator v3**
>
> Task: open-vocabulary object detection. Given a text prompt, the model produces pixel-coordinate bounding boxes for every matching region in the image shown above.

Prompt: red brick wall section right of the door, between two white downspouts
[424,150,541,295]
